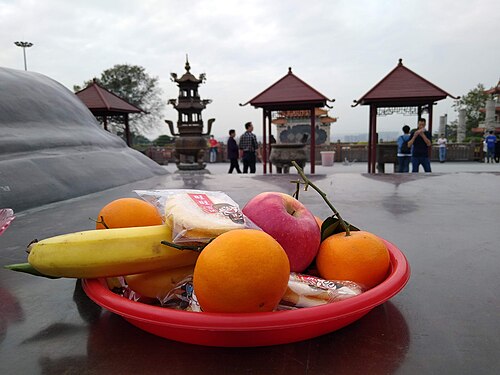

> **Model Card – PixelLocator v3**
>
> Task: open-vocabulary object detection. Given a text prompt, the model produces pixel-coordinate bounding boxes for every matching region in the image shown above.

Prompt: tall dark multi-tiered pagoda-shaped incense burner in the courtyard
[165,56,215,170]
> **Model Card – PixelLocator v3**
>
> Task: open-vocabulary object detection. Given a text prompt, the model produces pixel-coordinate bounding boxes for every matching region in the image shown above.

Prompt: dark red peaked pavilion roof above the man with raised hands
[356,59,456,105]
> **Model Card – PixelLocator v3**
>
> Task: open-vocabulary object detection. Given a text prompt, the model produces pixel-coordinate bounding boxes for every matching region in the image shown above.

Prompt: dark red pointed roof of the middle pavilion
[246,68,329,108]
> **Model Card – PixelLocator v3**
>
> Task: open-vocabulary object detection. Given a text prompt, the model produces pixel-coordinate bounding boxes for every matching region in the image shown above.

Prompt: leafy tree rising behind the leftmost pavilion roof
[73,64,165,133]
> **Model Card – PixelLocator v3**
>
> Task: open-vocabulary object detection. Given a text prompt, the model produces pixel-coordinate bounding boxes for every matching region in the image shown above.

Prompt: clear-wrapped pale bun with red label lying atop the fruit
[135,189,260,243]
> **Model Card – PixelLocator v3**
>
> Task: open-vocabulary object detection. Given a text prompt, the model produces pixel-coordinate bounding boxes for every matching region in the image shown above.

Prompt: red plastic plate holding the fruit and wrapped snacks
[83,240,410,347]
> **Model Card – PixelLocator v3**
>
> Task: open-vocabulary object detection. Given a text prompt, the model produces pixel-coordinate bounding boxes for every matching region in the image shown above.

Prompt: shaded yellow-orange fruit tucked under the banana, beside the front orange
[125,265,194,299]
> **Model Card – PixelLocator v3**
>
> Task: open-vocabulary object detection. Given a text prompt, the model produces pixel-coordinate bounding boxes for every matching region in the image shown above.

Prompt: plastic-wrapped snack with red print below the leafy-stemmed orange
[278,272,363,310]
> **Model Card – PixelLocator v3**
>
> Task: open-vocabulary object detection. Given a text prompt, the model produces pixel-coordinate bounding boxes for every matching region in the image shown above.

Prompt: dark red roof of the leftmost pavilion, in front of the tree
[75,82,144,114]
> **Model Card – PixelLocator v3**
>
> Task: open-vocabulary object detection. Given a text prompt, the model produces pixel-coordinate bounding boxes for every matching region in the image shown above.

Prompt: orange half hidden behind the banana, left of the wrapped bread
[95,198,163,229]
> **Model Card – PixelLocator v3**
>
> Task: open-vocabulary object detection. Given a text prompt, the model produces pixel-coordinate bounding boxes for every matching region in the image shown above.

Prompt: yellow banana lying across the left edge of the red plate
[28,225,199,278]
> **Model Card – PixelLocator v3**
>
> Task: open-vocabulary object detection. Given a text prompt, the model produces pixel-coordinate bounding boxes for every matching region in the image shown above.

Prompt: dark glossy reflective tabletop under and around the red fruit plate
[0,173,500,375]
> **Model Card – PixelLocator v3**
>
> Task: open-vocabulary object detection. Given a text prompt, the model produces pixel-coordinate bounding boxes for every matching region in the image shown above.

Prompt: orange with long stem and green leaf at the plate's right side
[316,231,390,289]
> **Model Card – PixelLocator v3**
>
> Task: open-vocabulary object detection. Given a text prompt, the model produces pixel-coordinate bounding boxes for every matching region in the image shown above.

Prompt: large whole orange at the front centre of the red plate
[193,229,290,313]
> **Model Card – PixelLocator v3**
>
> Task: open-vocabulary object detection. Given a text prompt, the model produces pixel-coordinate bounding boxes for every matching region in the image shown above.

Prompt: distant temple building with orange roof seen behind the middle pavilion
[272,108,337,145]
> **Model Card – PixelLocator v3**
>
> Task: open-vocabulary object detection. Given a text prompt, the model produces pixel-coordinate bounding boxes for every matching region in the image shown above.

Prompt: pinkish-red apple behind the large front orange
[242,192,321,272]
